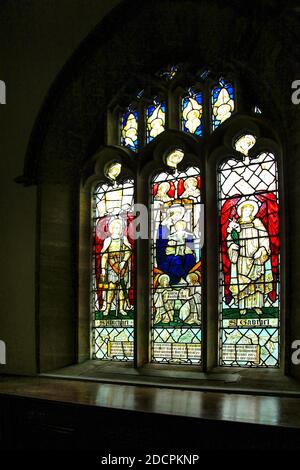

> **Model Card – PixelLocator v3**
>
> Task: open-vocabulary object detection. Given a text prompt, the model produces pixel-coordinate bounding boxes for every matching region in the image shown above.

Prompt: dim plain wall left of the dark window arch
[0,0,120,373]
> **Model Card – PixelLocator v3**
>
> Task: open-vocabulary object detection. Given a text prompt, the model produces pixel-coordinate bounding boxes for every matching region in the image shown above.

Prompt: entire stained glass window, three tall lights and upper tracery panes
[105,64,280,368]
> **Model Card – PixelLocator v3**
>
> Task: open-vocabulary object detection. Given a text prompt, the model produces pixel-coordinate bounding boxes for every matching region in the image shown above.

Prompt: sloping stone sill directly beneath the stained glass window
[40,360,300,397]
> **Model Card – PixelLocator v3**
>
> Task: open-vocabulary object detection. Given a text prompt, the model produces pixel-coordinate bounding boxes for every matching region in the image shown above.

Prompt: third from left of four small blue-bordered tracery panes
[182,89,203,137]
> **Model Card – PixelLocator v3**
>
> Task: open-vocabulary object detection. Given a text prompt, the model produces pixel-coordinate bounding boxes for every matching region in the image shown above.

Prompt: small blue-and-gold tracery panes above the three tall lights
[119,70,238,152]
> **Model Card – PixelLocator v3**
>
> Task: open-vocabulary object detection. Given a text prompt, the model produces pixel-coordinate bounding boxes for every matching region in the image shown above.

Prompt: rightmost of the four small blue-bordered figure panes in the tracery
[211,79,235,130]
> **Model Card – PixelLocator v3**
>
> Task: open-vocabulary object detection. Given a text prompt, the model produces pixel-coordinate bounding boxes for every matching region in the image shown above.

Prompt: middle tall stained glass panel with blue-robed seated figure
[151,151,202,364]
